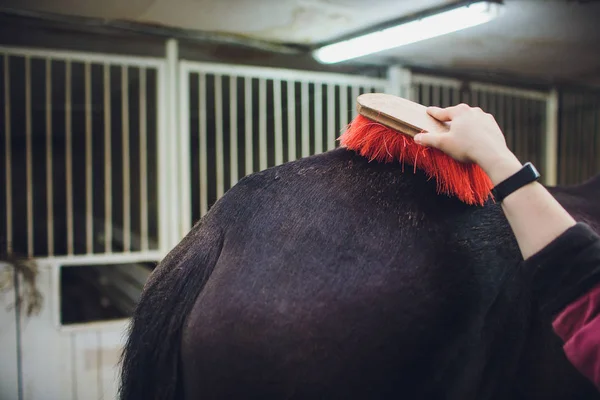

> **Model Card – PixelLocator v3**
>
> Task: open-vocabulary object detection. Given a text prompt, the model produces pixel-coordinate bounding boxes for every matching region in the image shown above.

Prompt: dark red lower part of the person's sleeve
[552,285,600,389]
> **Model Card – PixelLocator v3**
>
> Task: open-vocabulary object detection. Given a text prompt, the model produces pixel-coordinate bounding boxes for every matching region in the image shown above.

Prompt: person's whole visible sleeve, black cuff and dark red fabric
[526,223,600,390]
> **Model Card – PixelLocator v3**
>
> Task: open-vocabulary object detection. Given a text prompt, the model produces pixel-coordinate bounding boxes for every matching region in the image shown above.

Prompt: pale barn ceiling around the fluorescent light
[0,0,600,85]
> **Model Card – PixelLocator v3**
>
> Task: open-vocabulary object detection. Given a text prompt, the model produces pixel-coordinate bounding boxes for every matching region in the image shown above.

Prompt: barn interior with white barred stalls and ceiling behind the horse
[0,0,600,399]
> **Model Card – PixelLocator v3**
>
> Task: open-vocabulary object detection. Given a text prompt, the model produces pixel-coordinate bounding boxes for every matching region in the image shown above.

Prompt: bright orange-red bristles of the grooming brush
[338,115,493,205]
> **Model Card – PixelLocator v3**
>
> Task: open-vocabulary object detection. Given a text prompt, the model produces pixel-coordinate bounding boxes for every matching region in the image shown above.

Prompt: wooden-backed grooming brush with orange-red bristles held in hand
[338,93,493,205]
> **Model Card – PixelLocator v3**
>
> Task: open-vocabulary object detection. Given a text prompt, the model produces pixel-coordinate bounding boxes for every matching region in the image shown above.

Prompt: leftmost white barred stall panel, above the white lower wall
[0,47,169,257]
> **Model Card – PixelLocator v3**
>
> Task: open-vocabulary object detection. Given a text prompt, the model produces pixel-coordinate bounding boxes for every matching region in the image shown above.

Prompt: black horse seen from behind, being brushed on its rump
[120,149,600,400]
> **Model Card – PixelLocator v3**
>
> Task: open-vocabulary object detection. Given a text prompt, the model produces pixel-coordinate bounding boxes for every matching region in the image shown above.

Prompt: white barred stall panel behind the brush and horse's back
[180,60,388,222]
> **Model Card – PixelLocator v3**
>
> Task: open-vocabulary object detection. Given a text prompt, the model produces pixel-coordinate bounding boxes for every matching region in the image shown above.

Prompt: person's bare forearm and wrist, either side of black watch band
[482,153,575,259]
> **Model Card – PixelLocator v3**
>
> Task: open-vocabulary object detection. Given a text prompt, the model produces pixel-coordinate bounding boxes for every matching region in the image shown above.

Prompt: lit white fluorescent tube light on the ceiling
[313,1,501,64]
